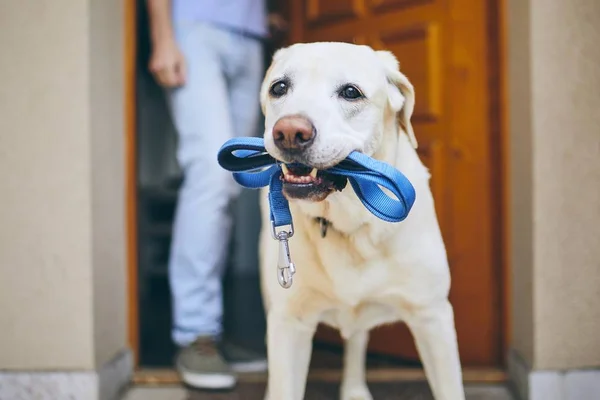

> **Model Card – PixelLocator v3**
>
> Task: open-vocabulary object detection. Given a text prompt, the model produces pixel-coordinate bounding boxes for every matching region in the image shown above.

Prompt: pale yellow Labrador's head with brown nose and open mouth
[261,42,416,201]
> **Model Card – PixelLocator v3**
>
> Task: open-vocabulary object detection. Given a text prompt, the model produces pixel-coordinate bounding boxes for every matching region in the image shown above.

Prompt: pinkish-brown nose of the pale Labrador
[273,115,317,151]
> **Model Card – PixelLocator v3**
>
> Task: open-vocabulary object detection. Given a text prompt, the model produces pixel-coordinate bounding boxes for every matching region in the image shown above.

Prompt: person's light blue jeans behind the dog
[168,22,263,346]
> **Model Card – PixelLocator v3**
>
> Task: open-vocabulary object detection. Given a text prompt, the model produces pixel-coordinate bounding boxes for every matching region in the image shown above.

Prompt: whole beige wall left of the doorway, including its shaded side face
[0,0,126,370]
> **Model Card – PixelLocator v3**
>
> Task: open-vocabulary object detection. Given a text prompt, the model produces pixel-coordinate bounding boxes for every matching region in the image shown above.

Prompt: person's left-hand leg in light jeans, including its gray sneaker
[169,24,236,388]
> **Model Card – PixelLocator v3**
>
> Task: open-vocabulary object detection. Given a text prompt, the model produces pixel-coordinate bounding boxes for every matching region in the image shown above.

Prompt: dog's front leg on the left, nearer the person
[266,309,316,400]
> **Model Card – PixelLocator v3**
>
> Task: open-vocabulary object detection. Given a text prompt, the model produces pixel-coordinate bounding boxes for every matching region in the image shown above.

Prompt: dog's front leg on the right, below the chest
[406,301,465,400]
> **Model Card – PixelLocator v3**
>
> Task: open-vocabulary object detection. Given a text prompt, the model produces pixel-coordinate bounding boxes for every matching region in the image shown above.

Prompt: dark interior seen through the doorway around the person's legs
[136,1,277,368]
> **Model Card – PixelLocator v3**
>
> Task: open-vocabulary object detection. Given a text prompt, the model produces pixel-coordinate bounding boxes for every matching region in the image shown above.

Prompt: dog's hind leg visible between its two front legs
[340,331,373,400]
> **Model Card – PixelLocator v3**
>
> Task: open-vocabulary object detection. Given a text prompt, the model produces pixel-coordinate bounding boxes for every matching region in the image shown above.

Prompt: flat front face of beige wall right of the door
[531,0,600,369]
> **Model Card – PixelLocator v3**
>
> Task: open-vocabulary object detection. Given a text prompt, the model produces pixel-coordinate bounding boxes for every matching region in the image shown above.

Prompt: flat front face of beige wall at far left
[0,1,93,369]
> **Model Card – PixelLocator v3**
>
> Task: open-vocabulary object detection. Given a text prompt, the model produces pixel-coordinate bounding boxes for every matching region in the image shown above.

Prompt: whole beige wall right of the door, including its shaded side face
[508,0,600,369]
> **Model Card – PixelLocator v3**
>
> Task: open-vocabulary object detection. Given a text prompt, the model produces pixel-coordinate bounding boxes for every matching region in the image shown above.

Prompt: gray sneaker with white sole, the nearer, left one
[176,337,236,389]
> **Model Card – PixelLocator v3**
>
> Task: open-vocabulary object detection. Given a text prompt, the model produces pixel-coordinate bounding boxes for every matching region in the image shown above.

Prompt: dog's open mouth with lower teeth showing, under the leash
[281,164,347,201]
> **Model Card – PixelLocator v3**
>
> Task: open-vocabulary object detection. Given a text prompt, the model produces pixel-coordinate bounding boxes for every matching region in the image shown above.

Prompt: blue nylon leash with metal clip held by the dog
[218,137,415,287]
